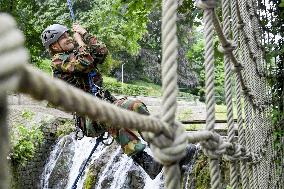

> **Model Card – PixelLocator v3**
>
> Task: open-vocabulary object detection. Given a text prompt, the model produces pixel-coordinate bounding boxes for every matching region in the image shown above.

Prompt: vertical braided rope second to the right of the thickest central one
[222,0,239,189]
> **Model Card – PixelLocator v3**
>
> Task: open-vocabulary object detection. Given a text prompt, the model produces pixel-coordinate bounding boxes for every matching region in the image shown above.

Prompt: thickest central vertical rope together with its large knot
[151,0,190,189]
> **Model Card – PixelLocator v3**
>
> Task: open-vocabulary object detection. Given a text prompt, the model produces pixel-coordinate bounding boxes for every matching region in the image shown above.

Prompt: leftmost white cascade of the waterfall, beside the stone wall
[41,134,106,189]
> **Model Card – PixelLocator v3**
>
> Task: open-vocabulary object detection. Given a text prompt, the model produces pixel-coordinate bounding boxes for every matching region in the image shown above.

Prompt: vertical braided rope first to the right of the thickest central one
[197,0,221,189]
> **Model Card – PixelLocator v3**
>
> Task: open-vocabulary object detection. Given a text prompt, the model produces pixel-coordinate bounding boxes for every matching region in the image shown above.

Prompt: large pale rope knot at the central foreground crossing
[143,122,188,166]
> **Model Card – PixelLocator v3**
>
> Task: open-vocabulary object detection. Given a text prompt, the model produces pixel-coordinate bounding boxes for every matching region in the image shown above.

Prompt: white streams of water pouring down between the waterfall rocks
[42,136,198,189]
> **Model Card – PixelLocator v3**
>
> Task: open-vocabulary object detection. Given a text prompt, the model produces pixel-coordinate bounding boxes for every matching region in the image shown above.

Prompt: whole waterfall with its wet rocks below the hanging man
[41,135,198,189]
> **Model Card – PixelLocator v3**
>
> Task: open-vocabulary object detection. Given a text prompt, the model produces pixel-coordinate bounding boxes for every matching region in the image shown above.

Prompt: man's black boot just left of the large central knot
[131,151,163,179]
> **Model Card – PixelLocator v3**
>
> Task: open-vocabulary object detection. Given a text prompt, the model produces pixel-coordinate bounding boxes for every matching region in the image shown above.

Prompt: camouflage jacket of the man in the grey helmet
[51,33,108,92]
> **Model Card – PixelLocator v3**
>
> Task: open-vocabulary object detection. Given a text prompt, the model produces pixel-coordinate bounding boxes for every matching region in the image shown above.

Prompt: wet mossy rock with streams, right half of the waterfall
[84,143,146,189]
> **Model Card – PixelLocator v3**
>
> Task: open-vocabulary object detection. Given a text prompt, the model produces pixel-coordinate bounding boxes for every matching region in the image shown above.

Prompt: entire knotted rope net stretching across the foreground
[0,0,278,189]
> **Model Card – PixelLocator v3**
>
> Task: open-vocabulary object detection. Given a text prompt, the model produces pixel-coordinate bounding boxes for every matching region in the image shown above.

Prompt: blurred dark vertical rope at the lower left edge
[0,91,9,189]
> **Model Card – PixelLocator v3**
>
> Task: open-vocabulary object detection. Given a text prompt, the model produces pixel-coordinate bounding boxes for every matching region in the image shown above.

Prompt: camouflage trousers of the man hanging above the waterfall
[76,98,149,156]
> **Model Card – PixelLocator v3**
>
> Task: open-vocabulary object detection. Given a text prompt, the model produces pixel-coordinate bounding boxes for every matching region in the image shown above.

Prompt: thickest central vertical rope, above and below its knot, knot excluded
[161,0,181,188]
